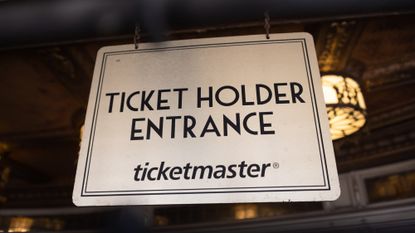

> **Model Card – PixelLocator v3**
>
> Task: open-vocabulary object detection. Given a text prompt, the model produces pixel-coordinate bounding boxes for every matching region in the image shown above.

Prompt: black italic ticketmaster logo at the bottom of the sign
[134,161,278,181]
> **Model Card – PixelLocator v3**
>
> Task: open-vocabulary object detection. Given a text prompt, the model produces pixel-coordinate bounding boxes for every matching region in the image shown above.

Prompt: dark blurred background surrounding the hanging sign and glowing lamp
[0,0,415,232]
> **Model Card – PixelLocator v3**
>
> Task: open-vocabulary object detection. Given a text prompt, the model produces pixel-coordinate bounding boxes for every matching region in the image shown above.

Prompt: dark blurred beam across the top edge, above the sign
[0,0,415,49]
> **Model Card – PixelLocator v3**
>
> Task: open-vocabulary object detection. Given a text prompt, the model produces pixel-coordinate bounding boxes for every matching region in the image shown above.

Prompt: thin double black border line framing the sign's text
[81,38,331,197]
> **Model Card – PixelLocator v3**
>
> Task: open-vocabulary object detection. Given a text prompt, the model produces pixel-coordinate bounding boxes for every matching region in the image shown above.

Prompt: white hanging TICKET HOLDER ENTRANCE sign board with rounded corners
[73,33,340,206]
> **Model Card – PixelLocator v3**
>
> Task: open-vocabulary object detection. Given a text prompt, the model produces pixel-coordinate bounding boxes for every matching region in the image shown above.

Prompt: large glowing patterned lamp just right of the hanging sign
[321,74,366,140]
